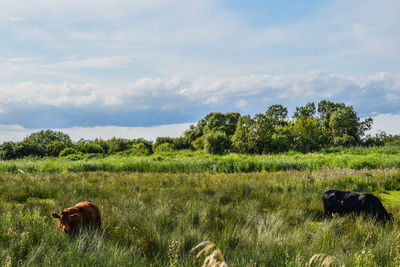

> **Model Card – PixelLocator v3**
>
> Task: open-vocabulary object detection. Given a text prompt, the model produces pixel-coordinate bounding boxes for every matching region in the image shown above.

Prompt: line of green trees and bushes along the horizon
[0,100,400,160]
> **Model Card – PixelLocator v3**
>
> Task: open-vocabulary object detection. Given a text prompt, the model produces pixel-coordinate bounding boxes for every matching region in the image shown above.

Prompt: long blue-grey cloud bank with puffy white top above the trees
[0,71,400,129]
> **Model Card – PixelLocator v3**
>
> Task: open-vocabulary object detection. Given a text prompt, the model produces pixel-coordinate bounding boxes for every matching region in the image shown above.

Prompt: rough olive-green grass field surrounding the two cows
[0,169,400,266]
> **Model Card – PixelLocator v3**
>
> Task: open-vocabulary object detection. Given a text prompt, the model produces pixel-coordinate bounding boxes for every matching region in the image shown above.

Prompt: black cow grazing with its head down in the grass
[323,189,393,222]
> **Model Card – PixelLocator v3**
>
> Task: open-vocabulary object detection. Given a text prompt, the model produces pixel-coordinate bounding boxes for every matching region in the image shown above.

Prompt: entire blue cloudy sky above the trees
[0,0,400,142]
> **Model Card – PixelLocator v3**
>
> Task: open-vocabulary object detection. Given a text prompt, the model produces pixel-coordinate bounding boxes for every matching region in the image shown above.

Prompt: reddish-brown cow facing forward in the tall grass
[51,200,101,234]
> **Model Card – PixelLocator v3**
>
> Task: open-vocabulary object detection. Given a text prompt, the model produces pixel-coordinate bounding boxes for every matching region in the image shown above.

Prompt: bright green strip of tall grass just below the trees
[0,146,400,173]
